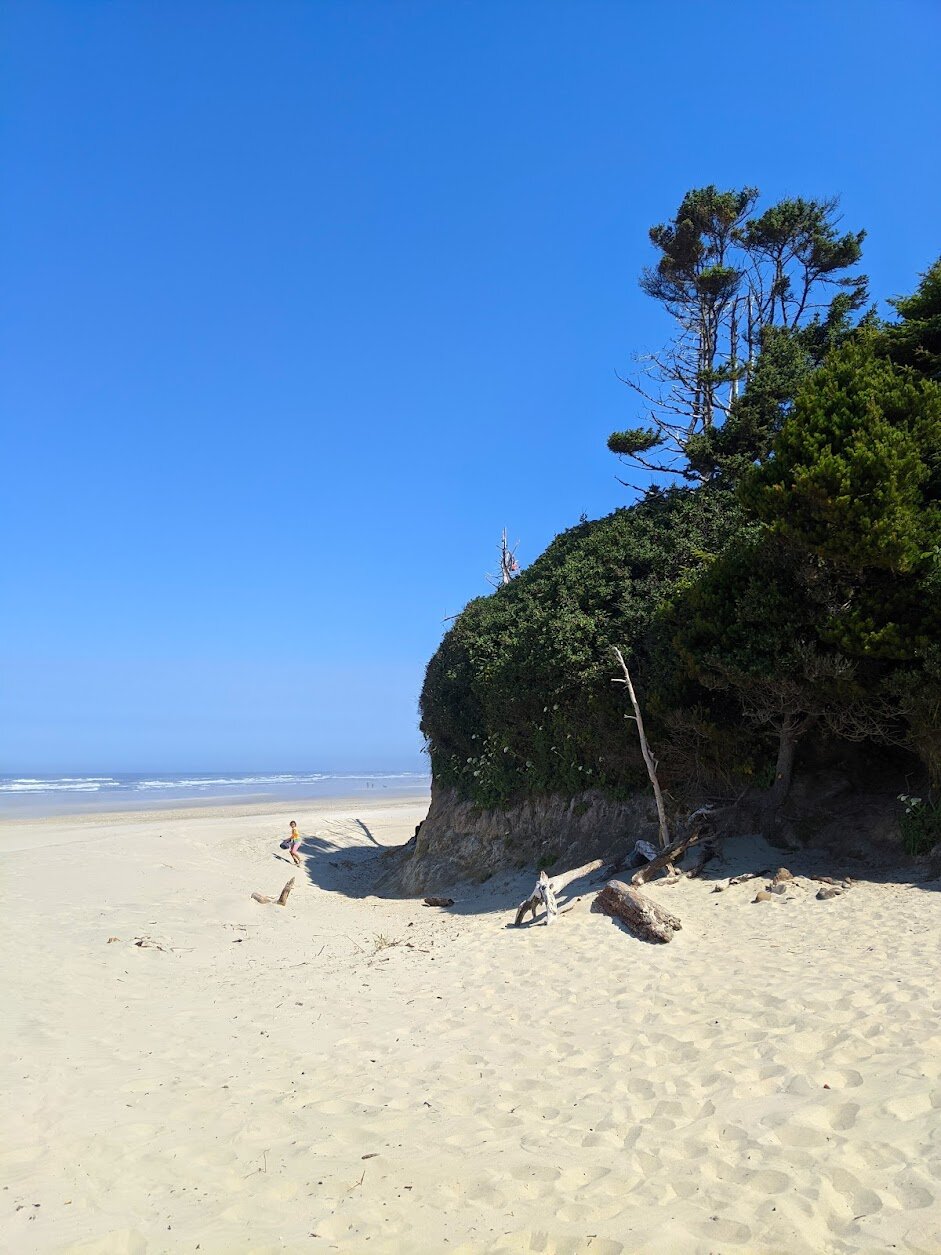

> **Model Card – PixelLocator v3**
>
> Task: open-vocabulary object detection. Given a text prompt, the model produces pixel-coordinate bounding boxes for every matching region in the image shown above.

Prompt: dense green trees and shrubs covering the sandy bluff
[422,188,941,841]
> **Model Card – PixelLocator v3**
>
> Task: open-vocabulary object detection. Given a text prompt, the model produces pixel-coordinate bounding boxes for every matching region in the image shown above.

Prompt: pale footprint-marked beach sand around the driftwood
[0,799,941,1255]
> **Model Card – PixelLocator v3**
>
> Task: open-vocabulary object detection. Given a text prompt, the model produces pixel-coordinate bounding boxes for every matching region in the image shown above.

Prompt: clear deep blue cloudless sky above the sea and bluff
[0,0,941,772]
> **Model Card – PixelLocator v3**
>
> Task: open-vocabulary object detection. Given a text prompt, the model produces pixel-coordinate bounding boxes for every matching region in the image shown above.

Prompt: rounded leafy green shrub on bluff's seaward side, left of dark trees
[422,488,739,806]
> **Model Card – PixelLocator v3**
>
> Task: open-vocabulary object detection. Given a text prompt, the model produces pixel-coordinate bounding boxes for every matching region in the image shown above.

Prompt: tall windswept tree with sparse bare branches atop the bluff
[607,184,867,479]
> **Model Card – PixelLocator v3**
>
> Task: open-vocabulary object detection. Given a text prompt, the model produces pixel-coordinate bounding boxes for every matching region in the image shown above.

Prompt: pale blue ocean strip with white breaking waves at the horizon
[0,772,430,820]
